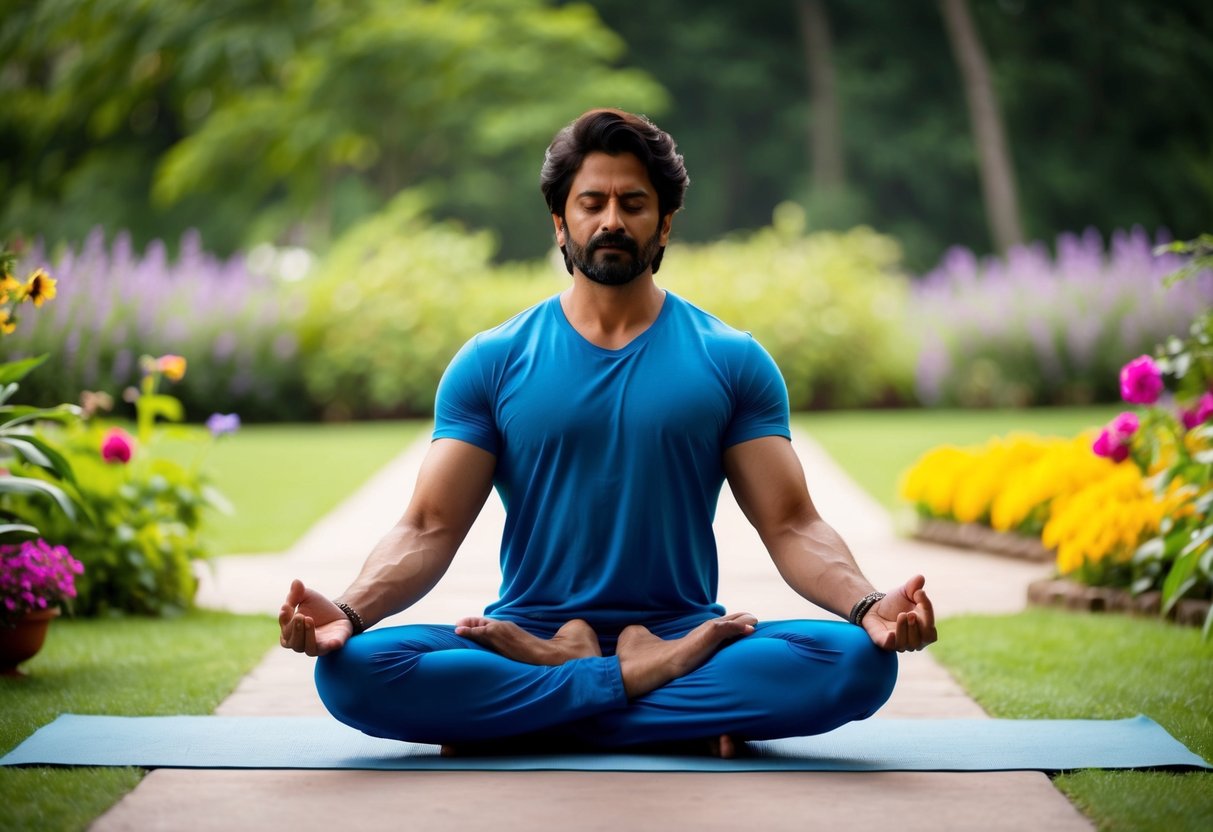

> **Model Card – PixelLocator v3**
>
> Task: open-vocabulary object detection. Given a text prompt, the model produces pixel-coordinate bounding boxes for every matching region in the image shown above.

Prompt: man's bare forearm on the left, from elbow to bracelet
[337,520,461,627]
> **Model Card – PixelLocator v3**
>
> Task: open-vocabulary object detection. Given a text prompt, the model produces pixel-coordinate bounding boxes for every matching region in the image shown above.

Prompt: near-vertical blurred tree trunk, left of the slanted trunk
[797,0,847,192]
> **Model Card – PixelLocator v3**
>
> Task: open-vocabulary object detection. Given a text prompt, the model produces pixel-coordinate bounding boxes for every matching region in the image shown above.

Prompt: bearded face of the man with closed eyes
[552,153,672,286]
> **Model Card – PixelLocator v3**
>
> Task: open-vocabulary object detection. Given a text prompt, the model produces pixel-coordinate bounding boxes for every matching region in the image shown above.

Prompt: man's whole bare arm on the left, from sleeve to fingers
[278,439,496,656]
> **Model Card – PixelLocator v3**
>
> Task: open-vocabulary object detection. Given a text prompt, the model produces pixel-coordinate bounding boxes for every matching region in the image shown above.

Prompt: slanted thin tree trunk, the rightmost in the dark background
[939,0,1024,251]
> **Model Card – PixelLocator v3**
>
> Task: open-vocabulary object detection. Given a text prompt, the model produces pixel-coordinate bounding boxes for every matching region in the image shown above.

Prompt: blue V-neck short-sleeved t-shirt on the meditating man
[434,292,791,632]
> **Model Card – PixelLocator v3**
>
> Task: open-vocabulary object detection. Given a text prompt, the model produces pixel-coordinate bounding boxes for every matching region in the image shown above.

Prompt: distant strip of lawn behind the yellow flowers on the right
[792,405,1122,512]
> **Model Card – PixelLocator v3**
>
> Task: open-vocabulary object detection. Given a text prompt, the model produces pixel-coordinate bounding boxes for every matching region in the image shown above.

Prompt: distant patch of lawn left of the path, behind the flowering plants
[161,421,428,554]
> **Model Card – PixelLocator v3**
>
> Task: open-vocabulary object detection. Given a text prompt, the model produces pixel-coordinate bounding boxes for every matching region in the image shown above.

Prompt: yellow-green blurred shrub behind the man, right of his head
[657,204,913,410]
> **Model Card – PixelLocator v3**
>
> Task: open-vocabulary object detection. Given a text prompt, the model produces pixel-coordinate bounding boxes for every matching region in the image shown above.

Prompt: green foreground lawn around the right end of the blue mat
[932,610,1213,832]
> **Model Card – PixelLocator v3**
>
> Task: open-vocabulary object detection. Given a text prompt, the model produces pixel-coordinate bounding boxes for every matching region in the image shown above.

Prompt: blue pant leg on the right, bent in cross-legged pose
[573,621,898,746]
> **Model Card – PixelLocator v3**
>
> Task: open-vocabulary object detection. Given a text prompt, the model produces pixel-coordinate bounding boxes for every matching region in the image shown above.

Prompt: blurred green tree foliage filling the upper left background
[0,0,665,259]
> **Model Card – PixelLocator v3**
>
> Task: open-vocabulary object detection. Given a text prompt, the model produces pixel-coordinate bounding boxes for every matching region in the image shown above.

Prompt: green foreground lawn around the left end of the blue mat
[0,611,277,831]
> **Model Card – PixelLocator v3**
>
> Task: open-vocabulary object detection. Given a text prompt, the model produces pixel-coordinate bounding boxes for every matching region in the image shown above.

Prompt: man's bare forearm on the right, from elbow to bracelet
[764,517,873,617]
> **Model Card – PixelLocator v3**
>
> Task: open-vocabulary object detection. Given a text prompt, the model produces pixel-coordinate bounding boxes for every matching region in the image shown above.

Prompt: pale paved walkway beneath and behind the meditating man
[93,435,1092,832]
